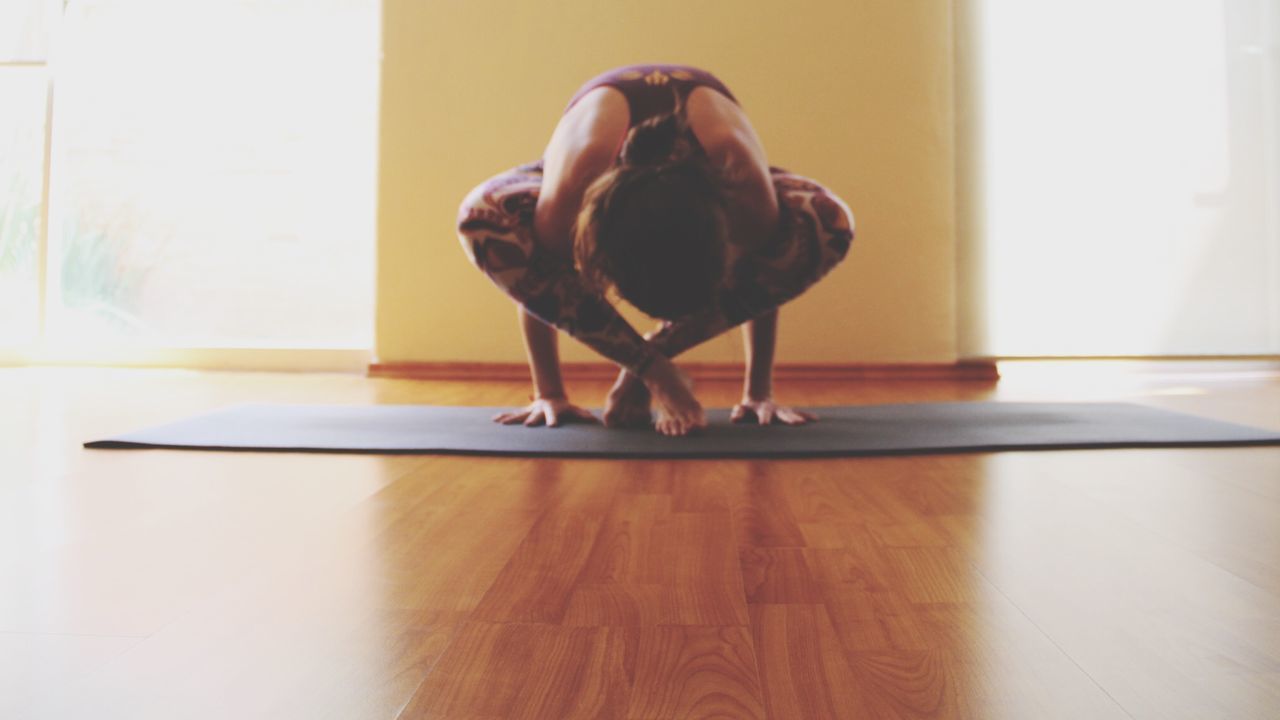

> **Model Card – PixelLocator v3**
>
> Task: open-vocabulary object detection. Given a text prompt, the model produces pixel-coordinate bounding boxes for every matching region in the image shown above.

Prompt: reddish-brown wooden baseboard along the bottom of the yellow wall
[369,361,1000,382]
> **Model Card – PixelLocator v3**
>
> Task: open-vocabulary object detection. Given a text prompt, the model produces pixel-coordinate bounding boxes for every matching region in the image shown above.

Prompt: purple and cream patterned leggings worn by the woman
[458,163,854,372]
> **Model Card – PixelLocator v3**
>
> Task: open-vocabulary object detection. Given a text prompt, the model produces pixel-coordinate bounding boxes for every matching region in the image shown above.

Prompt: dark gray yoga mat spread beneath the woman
[86,402,1280,457]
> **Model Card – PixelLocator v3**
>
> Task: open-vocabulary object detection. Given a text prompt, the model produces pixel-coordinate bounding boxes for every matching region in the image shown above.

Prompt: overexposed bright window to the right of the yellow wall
[970,0,1280,356]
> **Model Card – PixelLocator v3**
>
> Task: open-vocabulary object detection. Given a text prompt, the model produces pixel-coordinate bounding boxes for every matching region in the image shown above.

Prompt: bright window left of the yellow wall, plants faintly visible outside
[0,0,379,354]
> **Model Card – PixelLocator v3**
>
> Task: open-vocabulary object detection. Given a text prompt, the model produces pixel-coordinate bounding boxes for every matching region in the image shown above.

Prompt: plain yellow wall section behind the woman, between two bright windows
[376,0,955,363]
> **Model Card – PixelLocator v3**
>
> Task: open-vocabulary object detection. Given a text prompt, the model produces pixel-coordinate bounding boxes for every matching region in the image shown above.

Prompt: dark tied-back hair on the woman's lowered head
[573,106,728,320]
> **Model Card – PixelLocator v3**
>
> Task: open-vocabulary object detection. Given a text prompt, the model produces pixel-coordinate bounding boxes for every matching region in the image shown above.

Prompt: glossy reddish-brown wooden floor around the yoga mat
[0,365,1280,720]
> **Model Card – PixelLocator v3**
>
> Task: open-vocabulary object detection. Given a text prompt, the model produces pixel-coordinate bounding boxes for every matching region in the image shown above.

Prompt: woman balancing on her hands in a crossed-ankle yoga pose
[458,65,854,436]
